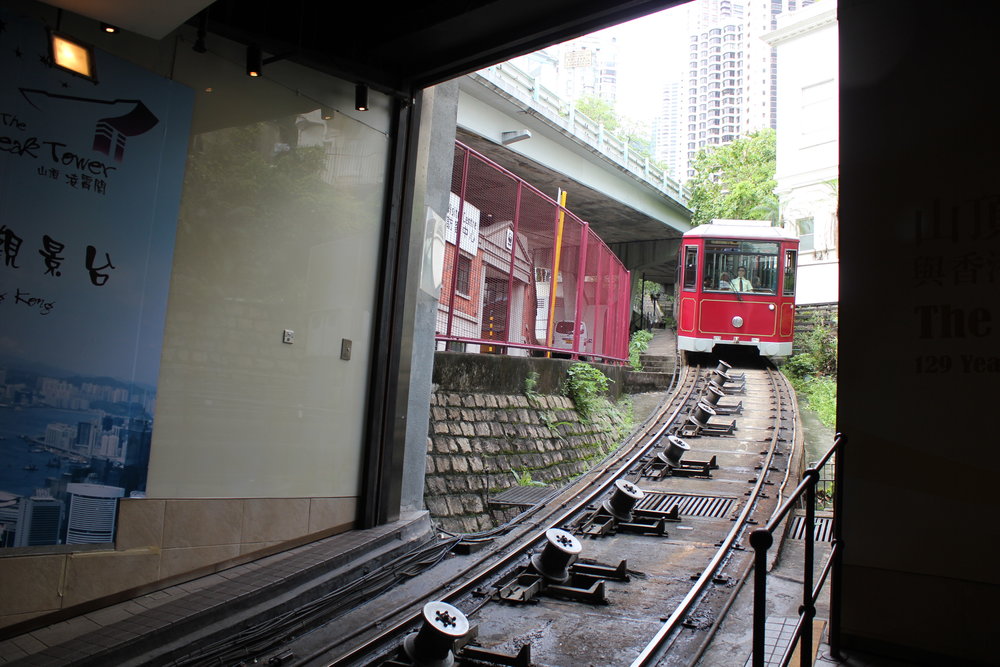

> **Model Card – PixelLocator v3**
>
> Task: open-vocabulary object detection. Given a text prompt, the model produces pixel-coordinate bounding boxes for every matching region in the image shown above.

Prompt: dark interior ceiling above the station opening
[200,0,686,95]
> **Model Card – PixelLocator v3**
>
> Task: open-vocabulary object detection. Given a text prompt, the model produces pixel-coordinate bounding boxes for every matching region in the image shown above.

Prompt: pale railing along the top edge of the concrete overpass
[472,62,691,206]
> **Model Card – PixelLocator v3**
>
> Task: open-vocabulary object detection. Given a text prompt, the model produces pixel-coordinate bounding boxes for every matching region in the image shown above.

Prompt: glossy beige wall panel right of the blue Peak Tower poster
[148,47,391,498]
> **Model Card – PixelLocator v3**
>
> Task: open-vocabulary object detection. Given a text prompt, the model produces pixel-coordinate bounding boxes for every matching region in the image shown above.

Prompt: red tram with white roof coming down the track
[675,220,799,357]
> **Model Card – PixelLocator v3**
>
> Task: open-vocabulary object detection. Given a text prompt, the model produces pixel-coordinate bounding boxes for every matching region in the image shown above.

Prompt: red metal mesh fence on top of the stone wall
[436,142,631,362]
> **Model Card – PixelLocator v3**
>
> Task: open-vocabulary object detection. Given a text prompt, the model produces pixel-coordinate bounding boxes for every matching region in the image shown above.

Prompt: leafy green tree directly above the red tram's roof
[688,129,779,225]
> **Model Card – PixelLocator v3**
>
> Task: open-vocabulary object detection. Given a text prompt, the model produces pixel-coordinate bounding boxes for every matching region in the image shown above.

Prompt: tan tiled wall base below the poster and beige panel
[0,498,357,627]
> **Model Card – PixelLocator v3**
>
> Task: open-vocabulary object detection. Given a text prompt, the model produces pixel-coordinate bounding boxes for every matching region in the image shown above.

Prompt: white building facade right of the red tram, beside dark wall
[765,0,839,304]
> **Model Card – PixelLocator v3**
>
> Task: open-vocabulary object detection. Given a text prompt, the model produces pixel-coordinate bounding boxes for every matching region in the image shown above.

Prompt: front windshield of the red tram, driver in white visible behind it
[702,239,778,294]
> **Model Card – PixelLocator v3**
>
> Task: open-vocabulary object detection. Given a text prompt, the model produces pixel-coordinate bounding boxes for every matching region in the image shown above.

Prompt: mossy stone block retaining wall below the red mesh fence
[424,387,621,533]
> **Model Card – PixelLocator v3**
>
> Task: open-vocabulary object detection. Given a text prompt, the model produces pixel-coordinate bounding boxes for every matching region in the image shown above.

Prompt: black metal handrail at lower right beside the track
[750,433,846,667]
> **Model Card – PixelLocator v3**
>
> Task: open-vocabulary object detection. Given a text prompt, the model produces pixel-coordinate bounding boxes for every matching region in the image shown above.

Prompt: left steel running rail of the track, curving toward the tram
[312,366,702,667]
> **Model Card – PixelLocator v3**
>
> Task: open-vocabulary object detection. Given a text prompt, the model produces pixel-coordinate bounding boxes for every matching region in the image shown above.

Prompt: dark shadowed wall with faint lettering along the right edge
[837,0,1000,665]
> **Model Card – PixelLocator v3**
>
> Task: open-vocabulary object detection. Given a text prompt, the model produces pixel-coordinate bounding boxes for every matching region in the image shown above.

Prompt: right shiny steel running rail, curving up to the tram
[631,369,784,667]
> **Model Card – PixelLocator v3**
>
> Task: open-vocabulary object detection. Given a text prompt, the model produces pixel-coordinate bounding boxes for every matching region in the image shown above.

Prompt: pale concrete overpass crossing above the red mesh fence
[456,64,691,284]
